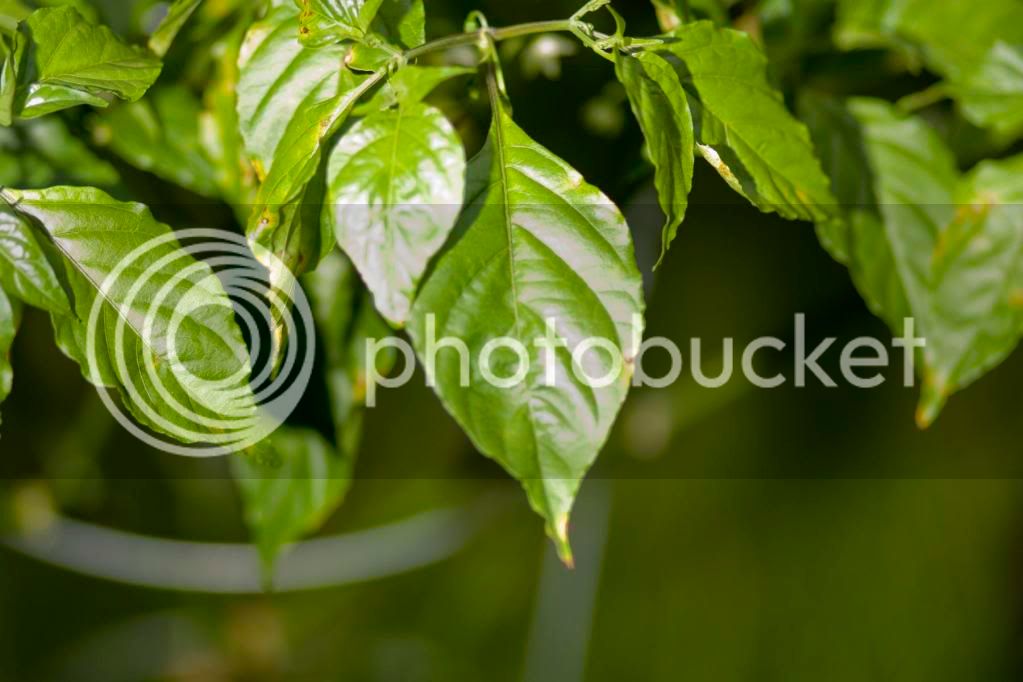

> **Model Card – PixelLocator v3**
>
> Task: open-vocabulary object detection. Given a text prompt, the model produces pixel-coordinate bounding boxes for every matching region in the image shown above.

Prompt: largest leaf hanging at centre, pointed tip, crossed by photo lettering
[409,102,643,560]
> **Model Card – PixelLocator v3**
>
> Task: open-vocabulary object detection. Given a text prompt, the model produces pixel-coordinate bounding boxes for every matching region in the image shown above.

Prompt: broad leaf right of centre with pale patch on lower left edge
[664,21,835,222]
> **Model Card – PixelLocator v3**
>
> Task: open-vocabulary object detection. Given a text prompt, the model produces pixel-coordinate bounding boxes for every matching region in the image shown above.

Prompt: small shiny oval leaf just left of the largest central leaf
[323,104,465,325]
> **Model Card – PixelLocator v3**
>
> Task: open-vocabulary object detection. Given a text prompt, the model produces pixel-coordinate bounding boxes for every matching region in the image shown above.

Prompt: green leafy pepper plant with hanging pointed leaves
[0,0,1023,562]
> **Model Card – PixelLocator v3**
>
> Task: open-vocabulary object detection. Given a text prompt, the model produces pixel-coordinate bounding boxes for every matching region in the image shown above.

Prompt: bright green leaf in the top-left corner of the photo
[18,7,161,119]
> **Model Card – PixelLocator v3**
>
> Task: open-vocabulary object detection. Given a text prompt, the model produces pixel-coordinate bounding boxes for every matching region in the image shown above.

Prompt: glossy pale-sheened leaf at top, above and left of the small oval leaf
[237,4,351,174]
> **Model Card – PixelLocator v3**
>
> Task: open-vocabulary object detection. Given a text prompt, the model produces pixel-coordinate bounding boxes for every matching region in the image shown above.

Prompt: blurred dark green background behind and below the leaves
[0,0,1023,682]
